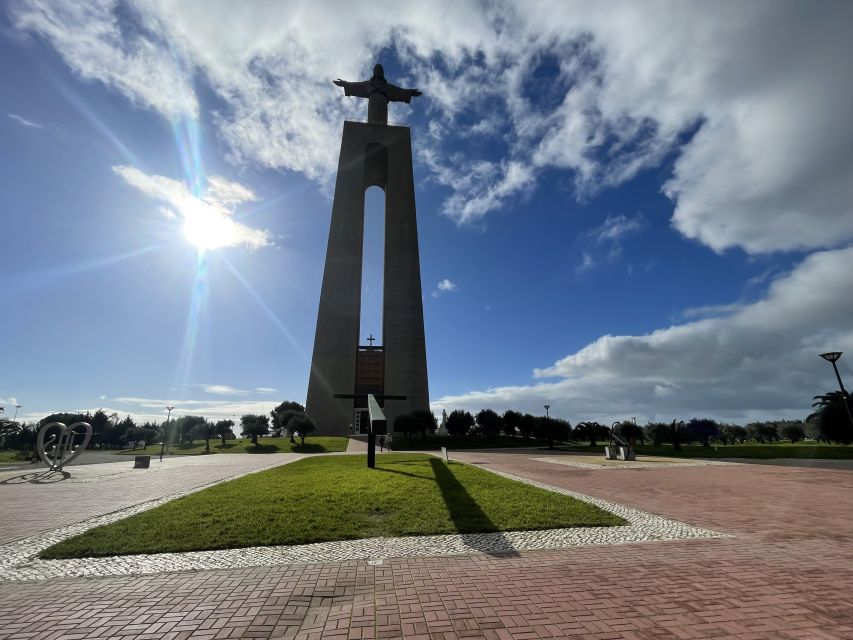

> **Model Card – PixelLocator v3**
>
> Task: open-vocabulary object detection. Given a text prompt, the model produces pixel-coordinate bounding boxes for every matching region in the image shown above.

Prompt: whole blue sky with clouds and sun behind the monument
[0,0,853,430]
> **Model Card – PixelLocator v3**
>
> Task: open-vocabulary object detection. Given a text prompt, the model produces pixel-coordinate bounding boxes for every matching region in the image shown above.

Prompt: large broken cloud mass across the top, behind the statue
[10,0,853,253]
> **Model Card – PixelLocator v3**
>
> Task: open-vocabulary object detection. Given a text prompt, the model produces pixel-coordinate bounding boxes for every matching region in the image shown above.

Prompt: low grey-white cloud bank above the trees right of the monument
[433,247,853,421]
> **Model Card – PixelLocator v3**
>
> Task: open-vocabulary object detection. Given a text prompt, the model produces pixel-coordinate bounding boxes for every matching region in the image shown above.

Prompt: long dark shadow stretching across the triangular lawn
[429,458,518,556]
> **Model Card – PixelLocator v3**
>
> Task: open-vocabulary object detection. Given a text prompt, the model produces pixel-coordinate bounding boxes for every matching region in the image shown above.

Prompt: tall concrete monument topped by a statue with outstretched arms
[306,65,429,434]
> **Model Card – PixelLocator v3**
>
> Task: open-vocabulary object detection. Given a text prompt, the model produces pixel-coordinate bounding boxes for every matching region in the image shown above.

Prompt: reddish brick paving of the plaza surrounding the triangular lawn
[0,451,853,640]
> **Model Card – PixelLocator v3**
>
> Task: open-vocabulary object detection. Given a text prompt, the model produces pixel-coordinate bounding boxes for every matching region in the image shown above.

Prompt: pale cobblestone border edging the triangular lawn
[0,454,729,581]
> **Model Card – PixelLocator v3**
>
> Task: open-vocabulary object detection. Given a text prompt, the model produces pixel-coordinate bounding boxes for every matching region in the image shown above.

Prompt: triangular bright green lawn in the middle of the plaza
[41,454,626,558]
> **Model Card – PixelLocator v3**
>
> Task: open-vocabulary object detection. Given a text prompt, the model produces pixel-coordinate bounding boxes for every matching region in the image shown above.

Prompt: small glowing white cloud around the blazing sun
[113,166,270,249]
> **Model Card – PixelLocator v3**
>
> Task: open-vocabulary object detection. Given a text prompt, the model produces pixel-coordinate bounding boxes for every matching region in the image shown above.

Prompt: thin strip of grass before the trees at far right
[557,442,853,460]
